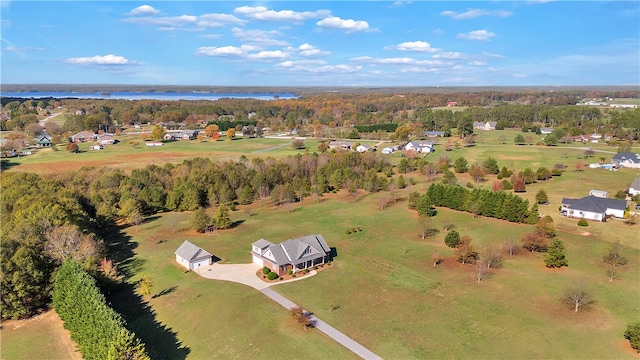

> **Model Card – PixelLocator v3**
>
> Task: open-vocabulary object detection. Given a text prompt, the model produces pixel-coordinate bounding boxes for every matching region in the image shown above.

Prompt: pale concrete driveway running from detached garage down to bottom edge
[195,263,381,360]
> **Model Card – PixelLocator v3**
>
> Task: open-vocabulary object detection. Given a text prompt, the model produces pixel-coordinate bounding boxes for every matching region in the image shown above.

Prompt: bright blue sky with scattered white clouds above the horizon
[0,0,640,86]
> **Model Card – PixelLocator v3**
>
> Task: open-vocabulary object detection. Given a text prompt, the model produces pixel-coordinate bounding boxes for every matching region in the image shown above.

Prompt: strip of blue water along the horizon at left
[0,91,297,100]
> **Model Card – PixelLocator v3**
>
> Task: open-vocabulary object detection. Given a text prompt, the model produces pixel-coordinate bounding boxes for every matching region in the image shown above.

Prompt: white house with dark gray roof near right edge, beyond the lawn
[560,195,627,221]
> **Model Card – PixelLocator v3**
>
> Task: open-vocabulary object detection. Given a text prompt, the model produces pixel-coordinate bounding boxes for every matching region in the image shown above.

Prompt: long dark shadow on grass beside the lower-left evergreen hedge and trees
[104,226,191,359]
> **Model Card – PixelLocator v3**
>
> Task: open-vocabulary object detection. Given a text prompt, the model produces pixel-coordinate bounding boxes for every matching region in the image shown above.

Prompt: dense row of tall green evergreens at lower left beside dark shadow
[53,260,149,360]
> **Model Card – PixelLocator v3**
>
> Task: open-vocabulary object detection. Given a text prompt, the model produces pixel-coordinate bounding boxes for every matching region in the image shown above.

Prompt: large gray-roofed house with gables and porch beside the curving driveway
[251,234,331,275]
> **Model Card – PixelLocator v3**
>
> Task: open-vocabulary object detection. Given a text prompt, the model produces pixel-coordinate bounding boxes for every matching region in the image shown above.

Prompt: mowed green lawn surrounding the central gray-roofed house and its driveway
[122,172,640,359]
